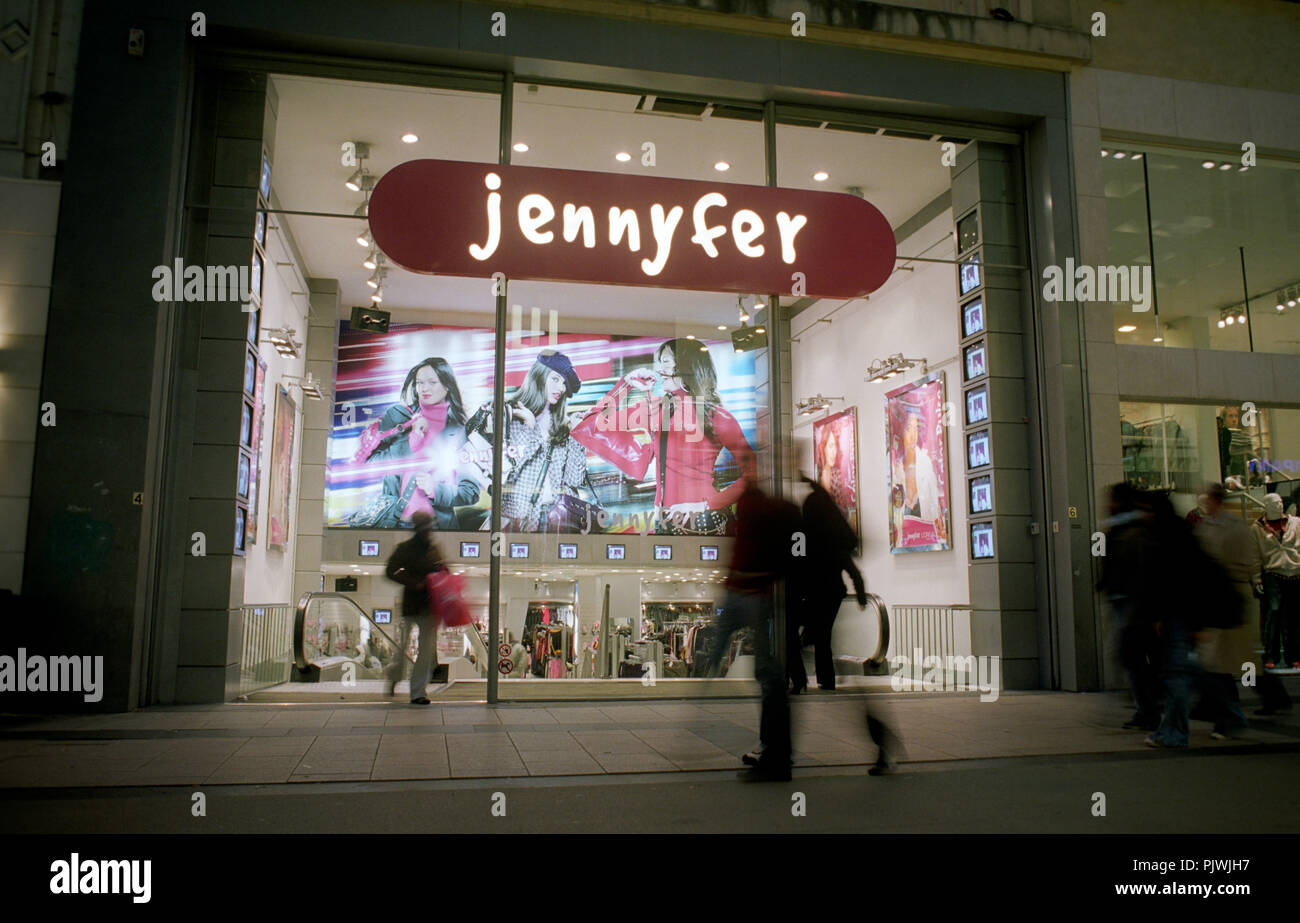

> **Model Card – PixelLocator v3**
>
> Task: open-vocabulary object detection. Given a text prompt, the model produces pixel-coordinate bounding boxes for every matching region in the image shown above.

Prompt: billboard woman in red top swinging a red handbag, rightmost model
[573,337,757,534]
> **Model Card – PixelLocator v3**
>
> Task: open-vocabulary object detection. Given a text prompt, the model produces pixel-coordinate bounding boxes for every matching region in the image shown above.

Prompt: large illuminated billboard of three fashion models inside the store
[325,322,758,534]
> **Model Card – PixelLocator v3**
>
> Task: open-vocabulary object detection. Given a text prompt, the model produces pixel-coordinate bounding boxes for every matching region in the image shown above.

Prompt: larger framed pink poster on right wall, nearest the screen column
[885,372,952,554]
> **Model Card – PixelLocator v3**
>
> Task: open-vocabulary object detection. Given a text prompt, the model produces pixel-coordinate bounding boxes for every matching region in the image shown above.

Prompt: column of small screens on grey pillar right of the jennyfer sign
[957,205,995,560]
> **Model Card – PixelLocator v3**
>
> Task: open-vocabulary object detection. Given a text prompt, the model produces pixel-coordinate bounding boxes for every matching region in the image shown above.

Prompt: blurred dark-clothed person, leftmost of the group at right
[1100,481,1161,731]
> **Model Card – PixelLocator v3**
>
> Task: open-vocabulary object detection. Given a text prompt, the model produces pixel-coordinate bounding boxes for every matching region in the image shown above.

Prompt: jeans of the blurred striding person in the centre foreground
[705,589,790,770]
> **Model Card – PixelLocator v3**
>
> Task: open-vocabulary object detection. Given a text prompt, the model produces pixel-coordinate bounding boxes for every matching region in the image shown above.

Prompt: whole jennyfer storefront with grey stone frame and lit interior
[27,5,1099,701]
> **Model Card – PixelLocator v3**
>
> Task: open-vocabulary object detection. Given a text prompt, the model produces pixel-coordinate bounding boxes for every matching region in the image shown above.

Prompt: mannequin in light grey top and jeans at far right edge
[1252,494,1300,670]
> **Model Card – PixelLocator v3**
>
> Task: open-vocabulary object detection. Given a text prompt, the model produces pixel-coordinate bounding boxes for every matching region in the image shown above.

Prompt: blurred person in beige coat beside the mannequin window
[1195,484,1258,740]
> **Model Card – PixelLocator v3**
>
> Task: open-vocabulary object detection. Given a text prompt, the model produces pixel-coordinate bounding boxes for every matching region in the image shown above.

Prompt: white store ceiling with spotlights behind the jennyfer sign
[272,75,949,333]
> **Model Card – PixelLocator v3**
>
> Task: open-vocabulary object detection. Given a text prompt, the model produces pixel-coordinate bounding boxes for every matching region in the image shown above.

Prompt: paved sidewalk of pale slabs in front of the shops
[0,692,1300,789]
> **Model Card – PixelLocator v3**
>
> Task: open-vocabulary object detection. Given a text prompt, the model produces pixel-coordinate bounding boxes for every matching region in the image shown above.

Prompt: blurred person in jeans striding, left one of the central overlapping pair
[705,478,801,781]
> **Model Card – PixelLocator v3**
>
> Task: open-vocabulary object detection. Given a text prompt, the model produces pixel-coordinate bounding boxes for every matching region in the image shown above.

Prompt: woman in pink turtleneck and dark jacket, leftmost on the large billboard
[367,356,478,529]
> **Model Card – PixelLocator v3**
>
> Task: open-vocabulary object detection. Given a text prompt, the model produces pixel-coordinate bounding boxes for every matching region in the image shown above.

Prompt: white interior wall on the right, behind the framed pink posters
[792,211,970,657]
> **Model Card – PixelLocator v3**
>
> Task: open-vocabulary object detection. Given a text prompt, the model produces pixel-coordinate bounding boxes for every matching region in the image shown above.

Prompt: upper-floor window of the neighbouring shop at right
[1093,150,1300,354]
